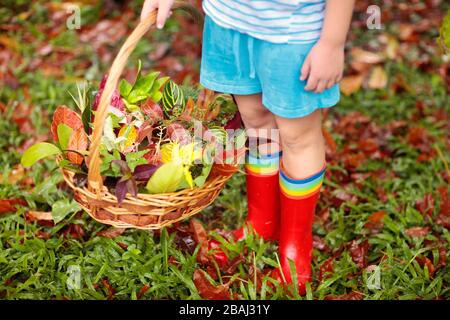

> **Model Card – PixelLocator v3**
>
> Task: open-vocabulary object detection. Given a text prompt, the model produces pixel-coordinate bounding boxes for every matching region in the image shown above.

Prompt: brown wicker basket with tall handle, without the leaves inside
[62,3,243,229]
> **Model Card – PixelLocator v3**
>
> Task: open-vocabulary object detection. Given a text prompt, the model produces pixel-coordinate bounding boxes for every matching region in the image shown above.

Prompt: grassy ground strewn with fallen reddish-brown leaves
[0,0,450,299]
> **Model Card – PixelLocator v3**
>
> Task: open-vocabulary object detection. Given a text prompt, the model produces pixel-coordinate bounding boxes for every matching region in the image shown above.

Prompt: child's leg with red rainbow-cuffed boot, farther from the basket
[276,110,325,293]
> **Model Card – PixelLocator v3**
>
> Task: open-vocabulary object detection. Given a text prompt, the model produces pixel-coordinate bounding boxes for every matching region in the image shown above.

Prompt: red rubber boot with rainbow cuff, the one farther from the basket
[278,166,325,294]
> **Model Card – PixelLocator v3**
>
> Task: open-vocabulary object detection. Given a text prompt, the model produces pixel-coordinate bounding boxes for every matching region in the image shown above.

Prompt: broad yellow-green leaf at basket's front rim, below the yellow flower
[147,162,183,193]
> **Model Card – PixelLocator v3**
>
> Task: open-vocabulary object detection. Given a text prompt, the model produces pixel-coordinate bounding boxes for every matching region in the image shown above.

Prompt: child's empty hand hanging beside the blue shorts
[300,40,344,93]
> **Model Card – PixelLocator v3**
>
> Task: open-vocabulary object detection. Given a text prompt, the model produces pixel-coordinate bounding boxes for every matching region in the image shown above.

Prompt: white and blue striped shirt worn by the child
[203,0,326,43]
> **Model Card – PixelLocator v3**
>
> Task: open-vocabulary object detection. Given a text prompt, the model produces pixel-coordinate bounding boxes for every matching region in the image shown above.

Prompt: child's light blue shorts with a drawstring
[200,16,340,118]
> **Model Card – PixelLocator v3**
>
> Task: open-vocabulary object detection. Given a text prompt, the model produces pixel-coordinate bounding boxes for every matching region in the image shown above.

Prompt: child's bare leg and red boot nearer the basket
[235,94,279,240]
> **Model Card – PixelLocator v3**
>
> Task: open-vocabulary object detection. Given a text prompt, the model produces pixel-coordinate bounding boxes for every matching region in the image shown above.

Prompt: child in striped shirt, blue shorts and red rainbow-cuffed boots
[142,0,354,293]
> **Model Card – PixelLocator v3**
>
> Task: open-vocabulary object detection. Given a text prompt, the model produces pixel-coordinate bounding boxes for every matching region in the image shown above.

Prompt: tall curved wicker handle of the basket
[88,1,187,196]
